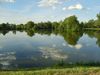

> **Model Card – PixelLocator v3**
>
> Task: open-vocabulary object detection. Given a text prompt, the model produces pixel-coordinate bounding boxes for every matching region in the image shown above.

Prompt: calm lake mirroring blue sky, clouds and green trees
[0,31,100,70]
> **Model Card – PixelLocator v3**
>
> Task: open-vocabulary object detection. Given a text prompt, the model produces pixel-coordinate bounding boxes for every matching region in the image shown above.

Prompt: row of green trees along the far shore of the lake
[0,13,100,31]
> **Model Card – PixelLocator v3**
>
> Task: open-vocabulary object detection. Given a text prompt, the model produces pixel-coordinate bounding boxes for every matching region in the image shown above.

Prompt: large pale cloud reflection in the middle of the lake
[39,47,68,60]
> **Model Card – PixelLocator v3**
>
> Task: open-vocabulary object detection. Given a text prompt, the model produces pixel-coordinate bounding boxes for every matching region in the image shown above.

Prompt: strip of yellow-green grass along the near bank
[0,67,100,75]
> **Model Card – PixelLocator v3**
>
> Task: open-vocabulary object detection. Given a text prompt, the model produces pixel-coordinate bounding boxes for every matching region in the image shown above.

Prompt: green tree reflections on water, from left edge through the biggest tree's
[0,30,83,45]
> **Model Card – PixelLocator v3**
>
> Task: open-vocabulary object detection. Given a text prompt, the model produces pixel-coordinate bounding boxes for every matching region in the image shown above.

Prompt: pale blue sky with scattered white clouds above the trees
[0,0,100,24]
